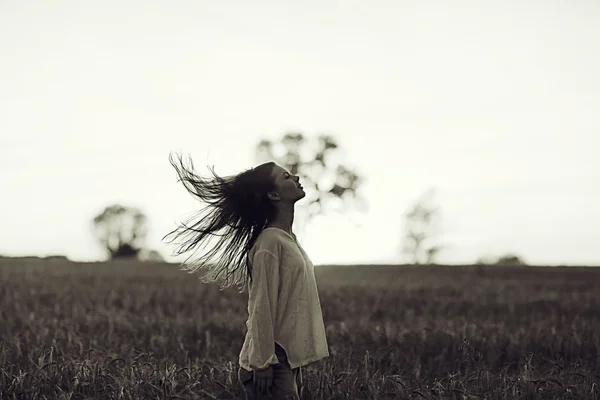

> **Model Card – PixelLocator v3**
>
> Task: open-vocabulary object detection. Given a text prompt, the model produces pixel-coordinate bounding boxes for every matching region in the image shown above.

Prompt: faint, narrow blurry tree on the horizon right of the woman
[403,189,444,264]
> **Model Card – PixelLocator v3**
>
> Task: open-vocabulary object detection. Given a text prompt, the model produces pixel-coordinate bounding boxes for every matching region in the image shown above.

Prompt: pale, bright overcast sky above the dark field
[0,0,600,265]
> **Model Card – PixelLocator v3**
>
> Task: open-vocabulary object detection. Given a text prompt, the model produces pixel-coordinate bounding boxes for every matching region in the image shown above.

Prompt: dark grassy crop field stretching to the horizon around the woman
[0,259,600,399]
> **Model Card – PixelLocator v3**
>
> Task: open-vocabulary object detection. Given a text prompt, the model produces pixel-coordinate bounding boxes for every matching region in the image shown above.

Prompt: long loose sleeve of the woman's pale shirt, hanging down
[248,250,279,370]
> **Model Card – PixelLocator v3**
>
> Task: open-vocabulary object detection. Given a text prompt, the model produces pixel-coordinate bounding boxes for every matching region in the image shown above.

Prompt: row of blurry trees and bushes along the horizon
[92,132,524,264]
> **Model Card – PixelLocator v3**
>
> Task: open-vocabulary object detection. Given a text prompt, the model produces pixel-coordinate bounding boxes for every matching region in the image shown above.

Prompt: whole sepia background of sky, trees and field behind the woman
[0,0,600,400]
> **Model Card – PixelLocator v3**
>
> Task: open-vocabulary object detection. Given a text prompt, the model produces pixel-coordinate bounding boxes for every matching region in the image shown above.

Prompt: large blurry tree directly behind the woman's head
[256,133,366,236]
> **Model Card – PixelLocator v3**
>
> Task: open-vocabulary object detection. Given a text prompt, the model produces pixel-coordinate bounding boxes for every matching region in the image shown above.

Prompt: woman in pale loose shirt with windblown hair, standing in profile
[167,152,329,399]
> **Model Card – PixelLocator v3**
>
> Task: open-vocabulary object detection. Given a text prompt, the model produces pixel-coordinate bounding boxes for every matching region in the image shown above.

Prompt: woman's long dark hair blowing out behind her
[163,154,276,292]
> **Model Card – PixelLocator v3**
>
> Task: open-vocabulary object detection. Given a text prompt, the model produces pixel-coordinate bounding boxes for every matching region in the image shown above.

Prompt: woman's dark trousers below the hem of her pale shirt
[238,343,302,400]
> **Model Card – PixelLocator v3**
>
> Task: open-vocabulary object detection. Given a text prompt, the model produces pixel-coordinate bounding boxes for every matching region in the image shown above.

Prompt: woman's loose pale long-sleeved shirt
[239,228,329,371]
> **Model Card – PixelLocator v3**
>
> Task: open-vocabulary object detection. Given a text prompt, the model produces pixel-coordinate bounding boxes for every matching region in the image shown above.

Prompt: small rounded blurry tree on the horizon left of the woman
[93,204,148,260]
